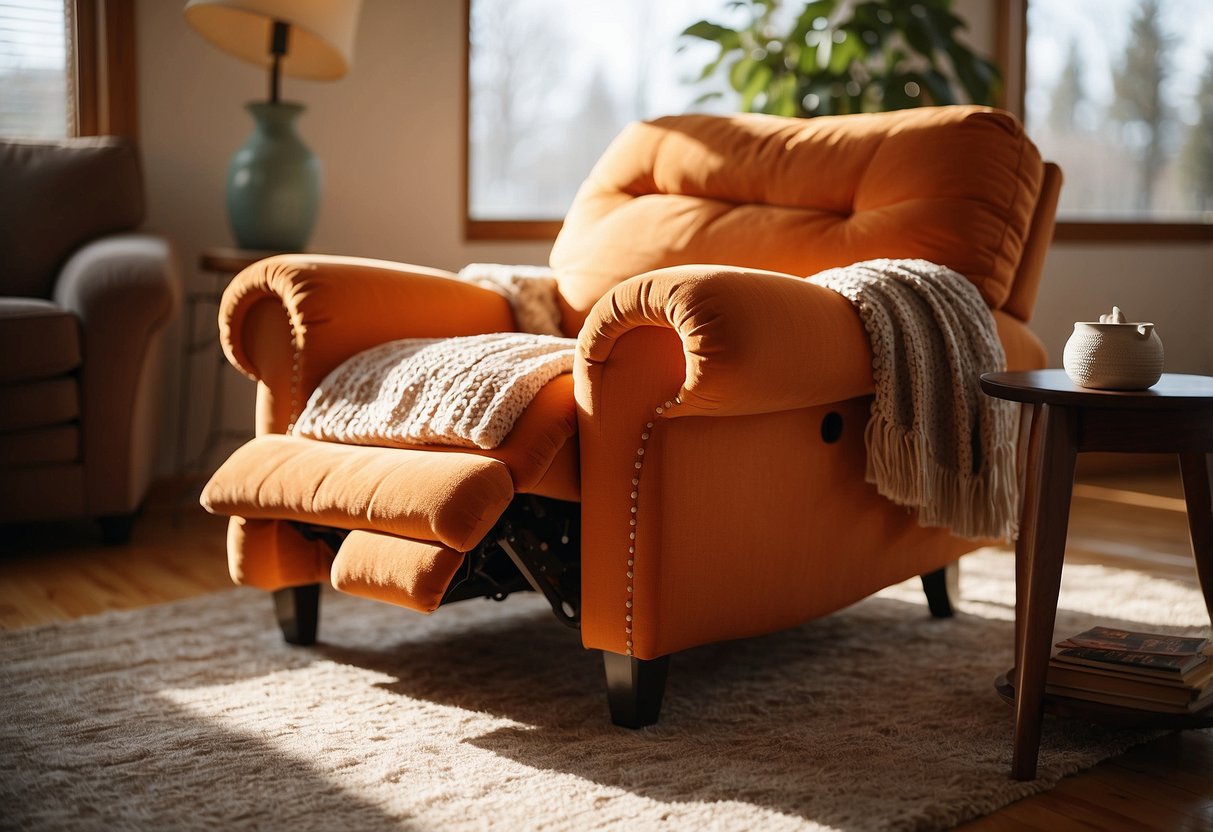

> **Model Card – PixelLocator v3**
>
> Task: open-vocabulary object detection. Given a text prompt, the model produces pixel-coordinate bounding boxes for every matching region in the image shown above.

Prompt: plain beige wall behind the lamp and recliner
[137,0,1213,473]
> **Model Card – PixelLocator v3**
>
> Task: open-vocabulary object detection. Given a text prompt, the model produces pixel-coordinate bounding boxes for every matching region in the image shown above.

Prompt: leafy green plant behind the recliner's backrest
[682,0,1001,116]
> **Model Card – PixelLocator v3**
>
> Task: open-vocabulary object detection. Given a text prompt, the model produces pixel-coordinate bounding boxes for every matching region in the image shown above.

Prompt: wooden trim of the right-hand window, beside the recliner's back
[996,0,1213,243]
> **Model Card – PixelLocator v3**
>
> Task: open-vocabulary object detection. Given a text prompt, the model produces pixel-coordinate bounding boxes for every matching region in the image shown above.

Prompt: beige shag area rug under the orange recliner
[0,549,1208,832]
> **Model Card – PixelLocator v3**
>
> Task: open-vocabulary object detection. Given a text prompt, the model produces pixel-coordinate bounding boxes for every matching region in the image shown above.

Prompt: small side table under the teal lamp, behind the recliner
[175,247,278,481]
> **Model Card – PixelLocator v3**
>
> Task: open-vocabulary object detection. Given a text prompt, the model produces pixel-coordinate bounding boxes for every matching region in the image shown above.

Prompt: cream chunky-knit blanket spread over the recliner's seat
[292,332,576,449]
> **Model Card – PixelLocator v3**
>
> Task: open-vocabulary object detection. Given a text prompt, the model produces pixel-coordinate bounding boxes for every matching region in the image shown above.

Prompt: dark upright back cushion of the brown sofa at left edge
[0,136,143,297]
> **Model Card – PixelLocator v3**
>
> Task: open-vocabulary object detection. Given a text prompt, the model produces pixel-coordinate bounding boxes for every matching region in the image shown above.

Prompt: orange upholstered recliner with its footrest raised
[203,107,1060,726]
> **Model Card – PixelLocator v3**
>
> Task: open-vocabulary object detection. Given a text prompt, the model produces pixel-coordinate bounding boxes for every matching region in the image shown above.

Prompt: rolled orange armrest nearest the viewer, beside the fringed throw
[577,266,873,417]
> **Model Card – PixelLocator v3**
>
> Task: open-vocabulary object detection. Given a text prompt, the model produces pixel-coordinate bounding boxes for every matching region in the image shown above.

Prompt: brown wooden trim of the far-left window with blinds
[68,0,138,141]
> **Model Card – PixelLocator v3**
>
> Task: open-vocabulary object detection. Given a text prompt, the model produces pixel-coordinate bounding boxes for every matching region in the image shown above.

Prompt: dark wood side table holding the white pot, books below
[981,370,1213,780]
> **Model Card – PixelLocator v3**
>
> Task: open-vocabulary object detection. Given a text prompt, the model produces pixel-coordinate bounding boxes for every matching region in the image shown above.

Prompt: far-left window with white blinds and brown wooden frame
[0,0,136,138]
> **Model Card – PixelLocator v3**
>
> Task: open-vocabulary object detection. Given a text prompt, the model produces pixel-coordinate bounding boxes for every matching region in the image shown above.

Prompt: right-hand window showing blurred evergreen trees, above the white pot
[1013,0,1213,239]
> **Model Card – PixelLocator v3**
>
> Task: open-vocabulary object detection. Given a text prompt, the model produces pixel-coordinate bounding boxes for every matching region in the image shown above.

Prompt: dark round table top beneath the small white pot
[981,370,1213,410]
